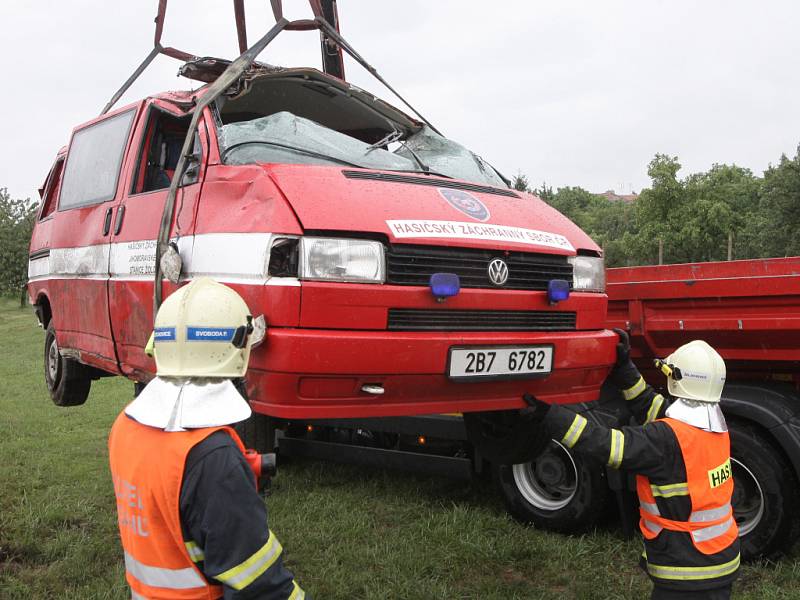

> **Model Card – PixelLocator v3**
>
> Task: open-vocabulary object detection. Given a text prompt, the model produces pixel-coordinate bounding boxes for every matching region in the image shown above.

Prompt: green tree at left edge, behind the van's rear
[0,188,36,305]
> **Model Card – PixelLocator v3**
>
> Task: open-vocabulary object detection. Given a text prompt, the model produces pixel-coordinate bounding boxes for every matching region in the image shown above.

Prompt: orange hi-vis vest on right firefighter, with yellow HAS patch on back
[636,418,739,555]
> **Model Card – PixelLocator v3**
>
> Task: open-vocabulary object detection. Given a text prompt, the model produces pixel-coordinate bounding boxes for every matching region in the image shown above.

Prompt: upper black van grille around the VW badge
[386,245,572,290]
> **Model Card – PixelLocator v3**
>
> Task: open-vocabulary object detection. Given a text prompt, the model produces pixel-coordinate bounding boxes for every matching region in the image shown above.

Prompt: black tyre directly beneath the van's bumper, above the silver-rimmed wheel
[464,410,550,464]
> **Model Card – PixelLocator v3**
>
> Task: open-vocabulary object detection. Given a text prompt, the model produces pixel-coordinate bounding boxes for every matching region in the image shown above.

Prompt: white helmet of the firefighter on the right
[655,340,725,403]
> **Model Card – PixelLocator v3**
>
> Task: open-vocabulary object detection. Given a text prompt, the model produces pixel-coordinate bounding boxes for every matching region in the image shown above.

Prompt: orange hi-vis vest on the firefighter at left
[108,412,244,600]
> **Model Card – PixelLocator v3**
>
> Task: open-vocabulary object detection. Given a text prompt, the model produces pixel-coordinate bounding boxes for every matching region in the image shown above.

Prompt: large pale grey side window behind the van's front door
[58,110,136,210]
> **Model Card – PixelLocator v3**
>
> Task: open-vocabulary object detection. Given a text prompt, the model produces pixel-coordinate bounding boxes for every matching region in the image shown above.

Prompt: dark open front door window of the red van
[131,109,199,194]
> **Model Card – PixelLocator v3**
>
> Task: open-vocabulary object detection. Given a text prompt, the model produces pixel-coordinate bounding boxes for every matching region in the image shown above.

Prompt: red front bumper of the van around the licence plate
[247,328,617,419]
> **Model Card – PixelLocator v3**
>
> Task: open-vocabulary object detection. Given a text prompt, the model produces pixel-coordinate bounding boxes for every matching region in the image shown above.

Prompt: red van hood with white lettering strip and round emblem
[263,164,600,255]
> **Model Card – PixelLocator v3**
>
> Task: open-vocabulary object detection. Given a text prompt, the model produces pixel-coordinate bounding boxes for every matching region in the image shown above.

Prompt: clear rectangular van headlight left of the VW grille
[299,237,386,283]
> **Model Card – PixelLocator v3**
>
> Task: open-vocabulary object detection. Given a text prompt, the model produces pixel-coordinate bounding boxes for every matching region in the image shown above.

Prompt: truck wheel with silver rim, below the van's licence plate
[494,440,611,533]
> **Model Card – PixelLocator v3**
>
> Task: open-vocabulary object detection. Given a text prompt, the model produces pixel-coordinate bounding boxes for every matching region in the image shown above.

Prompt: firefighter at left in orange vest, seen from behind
[108,278,306,600]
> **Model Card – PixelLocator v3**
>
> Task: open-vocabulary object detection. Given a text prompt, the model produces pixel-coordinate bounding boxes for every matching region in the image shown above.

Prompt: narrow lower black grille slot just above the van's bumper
[389,308,576,331]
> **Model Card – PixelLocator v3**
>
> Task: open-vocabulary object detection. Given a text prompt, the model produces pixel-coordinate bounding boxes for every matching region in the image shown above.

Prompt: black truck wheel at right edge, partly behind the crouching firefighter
[728,421,800,560]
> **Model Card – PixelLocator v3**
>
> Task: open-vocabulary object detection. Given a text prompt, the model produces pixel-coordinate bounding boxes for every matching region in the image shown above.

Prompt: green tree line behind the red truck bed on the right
[513,146,800,267]
